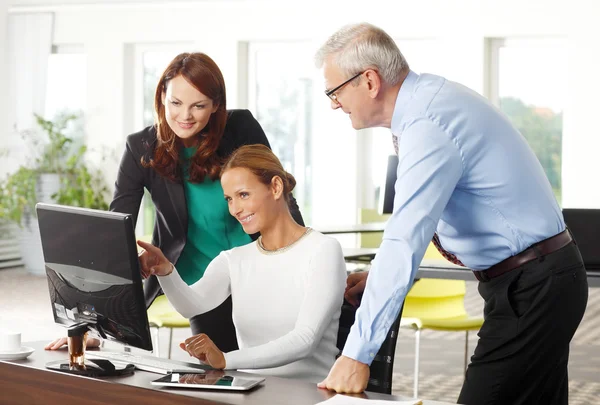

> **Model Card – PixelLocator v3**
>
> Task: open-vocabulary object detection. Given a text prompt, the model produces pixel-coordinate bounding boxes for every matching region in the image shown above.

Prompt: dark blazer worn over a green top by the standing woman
[110,110,304,306]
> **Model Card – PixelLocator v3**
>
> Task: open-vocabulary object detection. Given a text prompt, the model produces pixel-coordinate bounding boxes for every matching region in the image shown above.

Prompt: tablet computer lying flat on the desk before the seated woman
[152,370,265,391]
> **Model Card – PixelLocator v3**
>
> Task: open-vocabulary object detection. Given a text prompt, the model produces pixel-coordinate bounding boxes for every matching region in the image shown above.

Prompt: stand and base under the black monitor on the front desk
[46,323,135,377]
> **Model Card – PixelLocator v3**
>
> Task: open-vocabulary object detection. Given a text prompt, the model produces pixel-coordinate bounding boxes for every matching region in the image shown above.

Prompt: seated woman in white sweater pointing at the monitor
[51,145,346,382]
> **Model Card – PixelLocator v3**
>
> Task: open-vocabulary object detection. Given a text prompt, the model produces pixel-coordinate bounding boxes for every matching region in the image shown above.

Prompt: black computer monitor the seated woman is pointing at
[36,203,152,350]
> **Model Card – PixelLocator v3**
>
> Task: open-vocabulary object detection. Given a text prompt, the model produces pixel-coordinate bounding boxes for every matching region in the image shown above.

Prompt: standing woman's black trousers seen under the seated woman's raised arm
[190,295,238,353]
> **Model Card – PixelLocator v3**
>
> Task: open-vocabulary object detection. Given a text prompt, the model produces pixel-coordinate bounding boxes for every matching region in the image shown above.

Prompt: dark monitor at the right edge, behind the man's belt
[563,208,600,270]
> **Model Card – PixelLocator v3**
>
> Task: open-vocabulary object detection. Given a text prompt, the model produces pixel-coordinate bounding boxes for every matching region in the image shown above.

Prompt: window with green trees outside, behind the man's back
[489,38,568,203]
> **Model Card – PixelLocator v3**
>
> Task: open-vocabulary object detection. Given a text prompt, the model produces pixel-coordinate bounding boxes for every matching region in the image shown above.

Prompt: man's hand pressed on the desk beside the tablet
[317,356,370,394]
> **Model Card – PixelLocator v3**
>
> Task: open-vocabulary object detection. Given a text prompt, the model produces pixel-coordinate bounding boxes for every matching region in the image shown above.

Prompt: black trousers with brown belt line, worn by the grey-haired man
[458,243,588,405]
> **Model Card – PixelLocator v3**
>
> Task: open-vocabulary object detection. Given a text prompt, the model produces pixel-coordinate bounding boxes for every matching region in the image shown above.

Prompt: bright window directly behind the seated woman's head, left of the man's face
[249,44,315,223]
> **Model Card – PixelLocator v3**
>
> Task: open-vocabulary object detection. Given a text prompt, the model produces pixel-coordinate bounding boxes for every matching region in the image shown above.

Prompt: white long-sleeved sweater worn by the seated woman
[158,230,346,382]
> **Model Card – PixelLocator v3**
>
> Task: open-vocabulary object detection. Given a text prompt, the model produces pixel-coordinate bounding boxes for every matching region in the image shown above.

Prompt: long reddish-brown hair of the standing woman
[142,52,227,183]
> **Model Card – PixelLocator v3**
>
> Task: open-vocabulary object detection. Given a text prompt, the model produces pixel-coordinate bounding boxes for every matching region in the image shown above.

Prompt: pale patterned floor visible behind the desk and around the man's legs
[0,268,600,405]
